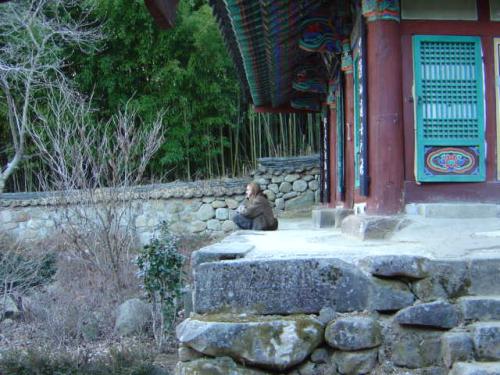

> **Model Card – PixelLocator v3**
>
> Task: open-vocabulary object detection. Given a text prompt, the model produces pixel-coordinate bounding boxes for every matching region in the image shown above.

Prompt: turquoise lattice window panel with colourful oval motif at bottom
[413,35,485,182]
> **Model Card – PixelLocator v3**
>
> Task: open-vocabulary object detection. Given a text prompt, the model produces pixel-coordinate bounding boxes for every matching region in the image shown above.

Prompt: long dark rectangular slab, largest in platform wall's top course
[194,258,413,315]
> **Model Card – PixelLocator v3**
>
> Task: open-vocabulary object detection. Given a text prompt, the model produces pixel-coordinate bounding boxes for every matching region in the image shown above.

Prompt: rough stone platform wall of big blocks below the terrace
[176,248,500,375]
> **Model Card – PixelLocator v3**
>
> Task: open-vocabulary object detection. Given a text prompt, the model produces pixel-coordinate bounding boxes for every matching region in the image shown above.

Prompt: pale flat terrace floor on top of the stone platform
[225,215,500,261]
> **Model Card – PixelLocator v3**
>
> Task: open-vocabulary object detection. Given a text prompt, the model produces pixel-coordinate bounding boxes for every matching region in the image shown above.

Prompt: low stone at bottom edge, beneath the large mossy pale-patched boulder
[175,357,272,375]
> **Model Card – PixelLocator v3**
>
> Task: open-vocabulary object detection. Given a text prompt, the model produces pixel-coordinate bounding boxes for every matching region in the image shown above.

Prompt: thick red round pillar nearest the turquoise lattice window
[363,3,404,215]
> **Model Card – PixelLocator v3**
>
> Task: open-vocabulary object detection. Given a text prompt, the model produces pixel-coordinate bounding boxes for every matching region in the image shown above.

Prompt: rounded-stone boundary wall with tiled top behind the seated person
[0,156,319,244]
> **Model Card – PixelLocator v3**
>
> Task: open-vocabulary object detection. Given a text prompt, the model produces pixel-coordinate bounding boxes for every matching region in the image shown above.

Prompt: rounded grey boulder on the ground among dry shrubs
[115,298,151,336]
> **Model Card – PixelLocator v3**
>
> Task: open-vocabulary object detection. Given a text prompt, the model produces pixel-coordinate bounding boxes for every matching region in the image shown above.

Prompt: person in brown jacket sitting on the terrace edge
[233,182,278,230]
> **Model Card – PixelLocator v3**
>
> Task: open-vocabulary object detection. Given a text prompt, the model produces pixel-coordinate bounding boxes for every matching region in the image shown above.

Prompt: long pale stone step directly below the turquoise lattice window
[405,203,500,219]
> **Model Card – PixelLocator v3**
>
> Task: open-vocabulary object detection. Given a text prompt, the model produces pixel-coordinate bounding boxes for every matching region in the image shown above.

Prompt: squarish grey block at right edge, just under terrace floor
[469,258,500,296]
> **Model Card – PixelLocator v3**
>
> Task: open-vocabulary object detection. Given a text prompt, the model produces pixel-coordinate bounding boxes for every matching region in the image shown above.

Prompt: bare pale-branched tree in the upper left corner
[0,0,101,193]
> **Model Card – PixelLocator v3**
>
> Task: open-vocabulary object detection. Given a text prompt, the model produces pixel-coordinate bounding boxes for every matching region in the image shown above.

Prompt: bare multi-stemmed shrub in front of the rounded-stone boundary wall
[30,89,164,286]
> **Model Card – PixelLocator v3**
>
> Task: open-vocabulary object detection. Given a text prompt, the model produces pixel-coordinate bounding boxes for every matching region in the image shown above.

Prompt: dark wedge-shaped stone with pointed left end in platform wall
[394,301,460,329]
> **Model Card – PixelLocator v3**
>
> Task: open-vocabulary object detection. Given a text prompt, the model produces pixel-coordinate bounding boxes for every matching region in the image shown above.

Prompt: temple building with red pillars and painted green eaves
[155,0,500,215]
